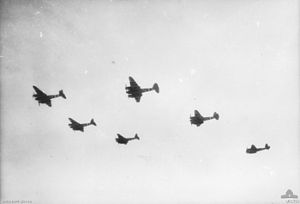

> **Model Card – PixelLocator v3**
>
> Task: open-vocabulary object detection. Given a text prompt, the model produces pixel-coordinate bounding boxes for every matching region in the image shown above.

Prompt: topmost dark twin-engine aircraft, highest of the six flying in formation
[125,77,159,102]
